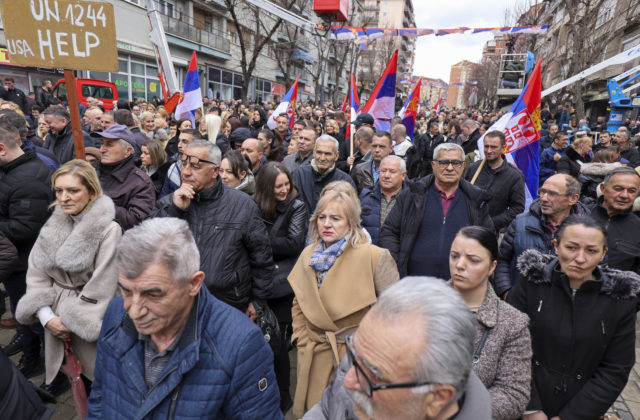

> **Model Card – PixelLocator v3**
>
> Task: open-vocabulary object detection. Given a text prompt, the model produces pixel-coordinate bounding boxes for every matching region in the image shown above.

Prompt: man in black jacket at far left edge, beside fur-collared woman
[0,127,53,377]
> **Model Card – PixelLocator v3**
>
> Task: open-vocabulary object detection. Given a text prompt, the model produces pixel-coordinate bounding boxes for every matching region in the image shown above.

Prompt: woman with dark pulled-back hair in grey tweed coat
[449,226,531,420]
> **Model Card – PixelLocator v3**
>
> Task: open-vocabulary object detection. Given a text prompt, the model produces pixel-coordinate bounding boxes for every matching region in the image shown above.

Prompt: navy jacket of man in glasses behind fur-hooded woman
[493,200,589,296]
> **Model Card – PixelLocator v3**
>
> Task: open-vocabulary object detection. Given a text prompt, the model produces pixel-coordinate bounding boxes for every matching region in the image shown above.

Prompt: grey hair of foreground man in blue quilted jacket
[116,217,200,286]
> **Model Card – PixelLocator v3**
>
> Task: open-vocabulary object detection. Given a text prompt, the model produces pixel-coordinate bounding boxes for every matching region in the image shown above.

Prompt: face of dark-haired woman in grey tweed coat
[449,235,498,291]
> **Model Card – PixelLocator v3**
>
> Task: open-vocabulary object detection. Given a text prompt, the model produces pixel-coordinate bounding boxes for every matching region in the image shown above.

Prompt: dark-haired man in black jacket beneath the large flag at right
[464,130,525,232]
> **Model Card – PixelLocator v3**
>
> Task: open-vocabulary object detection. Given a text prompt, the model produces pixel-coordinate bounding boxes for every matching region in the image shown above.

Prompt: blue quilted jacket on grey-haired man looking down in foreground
[87,287,283,420]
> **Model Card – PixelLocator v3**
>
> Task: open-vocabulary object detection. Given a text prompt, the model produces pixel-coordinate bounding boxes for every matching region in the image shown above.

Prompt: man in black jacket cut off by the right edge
[591,166,640,273]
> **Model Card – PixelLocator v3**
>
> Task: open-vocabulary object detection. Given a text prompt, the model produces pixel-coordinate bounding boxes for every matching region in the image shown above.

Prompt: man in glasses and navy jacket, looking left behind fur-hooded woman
[494,174,588,299]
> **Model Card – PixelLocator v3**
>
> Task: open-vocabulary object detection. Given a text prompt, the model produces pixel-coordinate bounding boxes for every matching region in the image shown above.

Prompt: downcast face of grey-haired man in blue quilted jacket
[118,264,204,338]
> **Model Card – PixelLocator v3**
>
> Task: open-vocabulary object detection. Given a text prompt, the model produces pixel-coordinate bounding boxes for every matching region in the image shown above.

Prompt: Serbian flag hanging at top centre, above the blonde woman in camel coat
[362,50,398,131]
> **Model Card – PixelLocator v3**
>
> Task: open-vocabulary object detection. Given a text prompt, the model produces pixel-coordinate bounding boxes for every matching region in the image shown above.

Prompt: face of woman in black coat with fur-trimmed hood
[553,225,607,281]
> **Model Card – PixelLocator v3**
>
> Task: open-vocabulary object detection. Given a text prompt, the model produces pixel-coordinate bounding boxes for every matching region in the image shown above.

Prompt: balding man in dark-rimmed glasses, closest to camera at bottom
[303,277,491,420]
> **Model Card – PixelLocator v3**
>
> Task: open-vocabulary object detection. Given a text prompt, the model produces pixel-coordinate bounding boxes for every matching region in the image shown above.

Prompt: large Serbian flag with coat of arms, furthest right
[478,60,542,208]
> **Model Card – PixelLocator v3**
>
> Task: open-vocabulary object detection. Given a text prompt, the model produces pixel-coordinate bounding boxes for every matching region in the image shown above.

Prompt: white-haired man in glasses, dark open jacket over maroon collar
[379,143,494,279]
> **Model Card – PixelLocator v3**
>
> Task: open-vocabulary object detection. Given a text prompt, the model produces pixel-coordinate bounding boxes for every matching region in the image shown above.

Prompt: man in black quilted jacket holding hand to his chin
[152,140,273,319]
